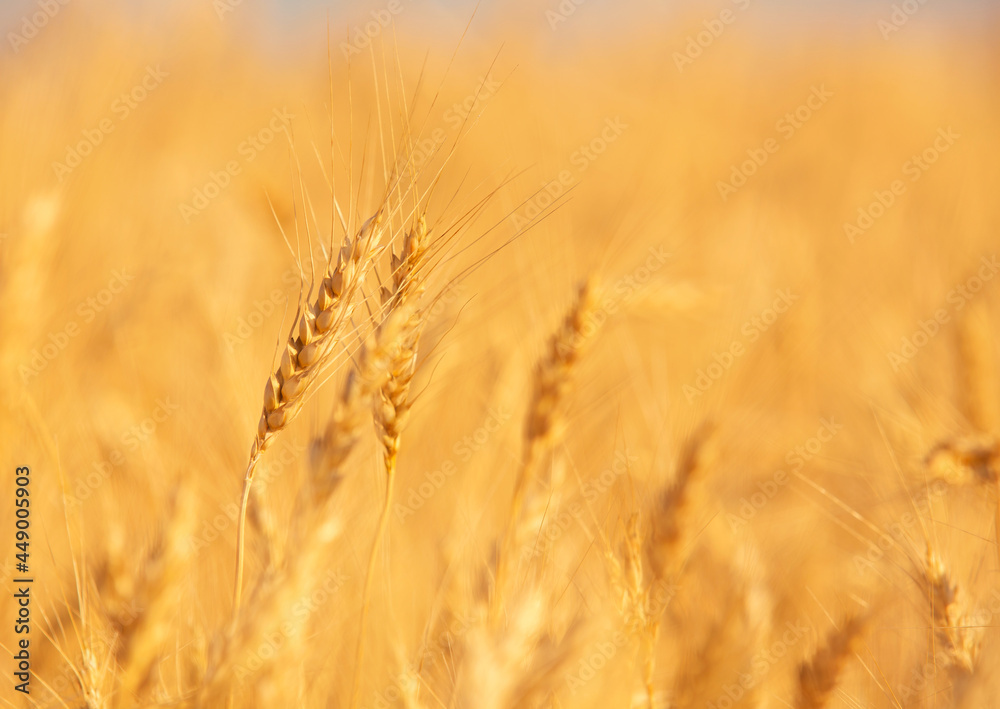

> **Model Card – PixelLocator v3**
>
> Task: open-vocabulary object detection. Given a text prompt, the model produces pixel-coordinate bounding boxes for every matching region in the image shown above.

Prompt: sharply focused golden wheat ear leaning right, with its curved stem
[233,209,383,616]
